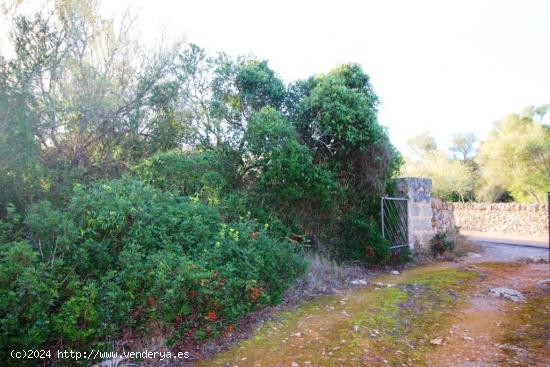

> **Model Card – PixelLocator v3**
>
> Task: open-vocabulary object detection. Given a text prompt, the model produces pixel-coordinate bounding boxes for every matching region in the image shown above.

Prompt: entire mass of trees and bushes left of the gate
[0,1,410,363]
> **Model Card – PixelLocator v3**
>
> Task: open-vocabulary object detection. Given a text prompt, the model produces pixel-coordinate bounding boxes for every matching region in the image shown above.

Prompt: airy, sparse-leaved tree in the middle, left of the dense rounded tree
[174,44,286,150]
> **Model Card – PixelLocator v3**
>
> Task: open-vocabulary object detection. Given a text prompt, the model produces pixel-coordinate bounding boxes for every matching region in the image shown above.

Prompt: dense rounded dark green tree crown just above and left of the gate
[287,64,401,192]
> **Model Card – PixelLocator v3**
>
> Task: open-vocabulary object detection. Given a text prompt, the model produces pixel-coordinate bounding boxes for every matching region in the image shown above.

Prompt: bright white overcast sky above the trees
[0,0,550,151]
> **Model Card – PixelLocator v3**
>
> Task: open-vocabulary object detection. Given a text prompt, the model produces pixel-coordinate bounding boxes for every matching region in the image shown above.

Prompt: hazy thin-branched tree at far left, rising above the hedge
[0,1,178,205]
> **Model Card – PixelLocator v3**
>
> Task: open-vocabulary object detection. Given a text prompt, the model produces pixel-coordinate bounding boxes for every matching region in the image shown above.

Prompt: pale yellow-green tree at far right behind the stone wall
[477,107,550,203]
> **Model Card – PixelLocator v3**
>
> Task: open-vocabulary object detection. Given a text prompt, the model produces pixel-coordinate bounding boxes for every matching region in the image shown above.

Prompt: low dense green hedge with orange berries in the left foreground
[0,178,305,362]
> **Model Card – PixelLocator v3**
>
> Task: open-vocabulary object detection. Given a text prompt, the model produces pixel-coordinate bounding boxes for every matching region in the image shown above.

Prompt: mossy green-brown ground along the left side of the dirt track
[199,265,476,367]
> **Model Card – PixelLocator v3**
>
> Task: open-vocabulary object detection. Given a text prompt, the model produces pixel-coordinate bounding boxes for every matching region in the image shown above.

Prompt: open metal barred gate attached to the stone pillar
[380,196,409,250]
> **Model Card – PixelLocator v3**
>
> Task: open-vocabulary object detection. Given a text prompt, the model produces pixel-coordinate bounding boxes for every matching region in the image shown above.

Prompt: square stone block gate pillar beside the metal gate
[397,177,435,248]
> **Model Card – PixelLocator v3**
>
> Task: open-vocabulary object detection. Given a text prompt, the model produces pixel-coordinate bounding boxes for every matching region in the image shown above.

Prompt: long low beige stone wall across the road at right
[451,203,548,236]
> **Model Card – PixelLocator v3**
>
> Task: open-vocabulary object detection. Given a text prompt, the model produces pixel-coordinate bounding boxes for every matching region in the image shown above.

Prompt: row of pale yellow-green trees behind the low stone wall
[401,106,550,203]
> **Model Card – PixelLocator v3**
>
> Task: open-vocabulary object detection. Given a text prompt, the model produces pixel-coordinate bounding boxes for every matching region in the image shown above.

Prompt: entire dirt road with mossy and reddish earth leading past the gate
[198,245,550,367]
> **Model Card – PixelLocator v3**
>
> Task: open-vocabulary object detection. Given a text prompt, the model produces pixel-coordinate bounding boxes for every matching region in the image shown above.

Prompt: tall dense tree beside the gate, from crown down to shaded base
[286,64,401,256]
